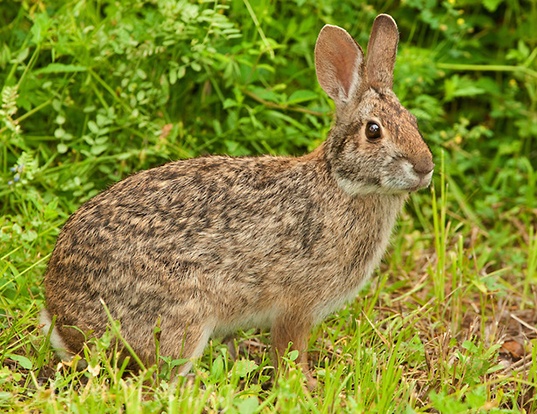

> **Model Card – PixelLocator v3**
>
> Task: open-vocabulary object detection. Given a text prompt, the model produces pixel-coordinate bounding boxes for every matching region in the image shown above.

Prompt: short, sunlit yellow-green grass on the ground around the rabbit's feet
[0,173,537,413]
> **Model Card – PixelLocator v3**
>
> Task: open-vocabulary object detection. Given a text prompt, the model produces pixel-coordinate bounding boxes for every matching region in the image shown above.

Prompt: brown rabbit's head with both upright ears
[315,14,434,195]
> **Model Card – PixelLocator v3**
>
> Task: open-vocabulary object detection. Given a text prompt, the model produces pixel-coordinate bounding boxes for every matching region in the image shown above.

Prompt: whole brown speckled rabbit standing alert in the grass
[41,14,434,387]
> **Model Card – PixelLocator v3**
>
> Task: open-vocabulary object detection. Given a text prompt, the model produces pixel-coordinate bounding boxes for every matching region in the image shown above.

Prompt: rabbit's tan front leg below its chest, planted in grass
[271,311,317,390]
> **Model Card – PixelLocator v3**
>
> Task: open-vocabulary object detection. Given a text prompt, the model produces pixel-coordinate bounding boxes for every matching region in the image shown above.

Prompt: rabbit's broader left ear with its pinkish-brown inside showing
[315,24,364,106]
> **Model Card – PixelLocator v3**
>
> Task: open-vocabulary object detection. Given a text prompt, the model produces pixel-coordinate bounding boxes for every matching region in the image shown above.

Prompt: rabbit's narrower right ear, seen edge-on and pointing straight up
[365,14,399,89]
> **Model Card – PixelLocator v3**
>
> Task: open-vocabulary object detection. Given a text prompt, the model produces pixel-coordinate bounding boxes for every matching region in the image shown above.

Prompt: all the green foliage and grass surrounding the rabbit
[0,0,537,413]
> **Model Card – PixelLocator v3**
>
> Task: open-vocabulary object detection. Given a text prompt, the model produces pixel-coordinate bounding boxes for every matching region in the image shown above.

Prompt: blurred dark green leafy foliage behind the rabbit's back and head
[0,0,537,215]
